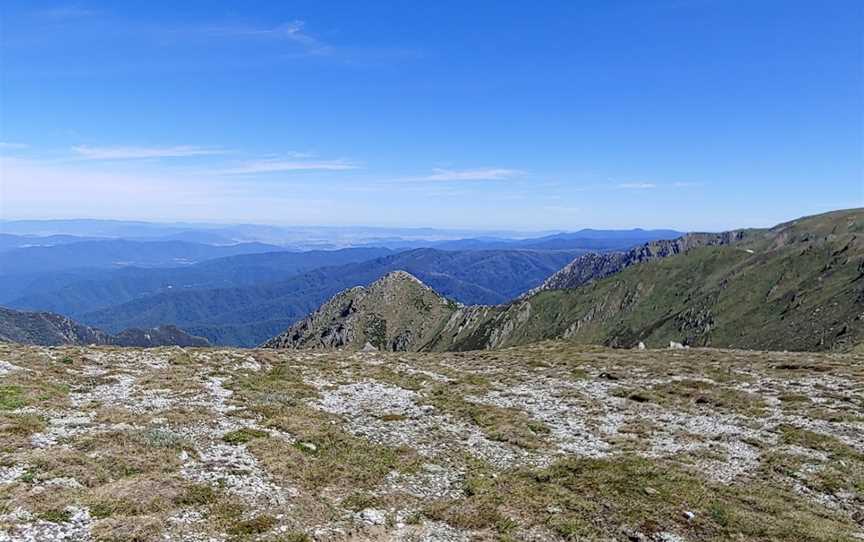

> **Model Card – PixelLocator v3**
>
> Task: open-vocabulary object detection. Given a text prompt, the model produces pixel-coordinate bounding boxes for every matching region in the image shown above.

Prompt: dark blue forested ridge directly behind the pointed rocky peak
[77,249,579,346]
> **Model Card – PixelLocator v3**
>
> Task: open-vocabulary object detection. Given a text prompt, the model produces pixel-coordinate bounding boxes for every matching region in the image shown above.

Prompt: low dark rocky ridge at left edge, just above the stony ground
[0,307,210,347]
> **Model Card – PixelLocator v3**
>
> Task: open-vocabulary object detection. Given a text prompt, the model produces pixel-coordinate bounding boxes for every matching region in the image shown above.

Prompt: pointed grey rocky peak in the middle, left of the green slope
[263,271,458,351]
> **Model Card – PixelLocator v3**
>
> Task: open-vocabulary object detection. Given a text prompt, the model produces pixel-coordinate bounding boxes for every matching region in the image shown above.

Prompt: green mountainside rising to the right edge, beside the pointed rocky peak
[270,209,864,351]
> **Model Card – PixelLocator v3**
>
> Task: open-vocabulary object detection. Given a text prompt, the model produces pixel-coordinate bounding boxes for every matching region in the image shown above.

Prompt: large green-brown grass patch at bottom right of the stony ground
[424,456,855,542]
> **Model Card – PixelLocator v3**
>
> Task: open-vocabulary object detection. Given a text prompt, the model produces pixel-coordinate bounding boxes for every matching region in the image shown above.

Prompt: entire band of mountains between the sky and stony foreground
[0,215,864,351]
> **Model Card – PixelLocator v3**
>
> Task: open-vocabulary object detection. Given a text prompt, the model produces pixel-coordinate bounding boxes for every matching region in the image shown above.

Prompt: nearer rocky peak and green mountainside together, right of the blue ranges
[267,209,864,351]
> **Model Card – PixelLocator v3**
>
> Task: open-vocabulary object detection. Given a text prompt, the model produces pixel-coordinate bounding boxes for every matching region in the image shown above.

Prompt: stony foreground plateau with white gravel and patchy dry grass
[0,343,864,542]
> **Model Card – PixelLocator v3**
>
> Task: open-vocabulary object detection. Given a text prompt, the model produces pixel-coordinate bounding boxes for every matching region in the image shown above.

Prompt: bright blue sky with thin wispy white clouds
[0,0,864,230]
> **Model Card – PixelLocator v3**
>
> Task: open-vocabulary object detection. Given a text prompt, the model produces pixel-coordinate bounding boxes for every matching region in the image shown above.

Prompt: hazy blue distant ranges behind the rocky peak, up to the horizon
[0,224,677,346]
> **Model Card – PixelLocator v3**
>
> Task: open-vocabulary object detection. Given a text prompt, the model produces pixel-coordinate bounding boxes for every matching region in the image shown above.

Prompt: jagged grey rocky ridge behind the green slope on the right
[530,230,752,293]
